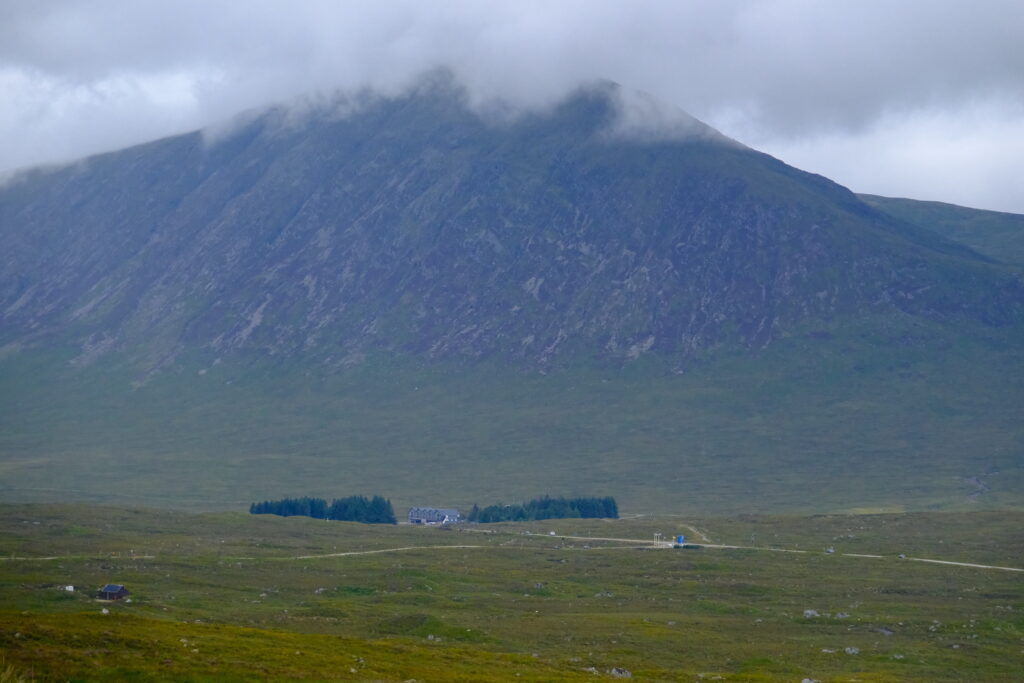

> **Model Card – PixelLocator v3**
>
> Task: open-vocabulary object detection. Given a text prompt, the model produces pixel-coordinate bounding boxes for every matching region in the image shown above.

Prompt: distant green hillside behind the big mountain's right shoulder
[857,195,1024,264]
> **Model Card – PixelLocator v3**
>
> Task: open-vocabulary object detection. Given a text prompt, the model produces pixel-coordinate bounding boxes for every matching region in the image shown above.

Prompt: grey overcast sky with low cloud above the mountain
[6,0,1024,213]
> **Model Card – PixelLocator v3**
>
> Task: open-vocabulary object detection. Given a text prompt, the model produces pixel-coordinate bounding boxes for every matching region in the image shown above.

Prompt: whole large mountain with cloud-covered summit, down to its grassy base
[0,79,1024,512]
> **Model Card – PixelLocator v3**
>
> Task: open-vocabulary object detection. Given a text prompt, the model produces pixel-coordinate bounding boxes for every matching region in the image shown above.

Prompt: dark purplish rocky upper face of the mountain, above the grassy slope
[0,80,1024,368]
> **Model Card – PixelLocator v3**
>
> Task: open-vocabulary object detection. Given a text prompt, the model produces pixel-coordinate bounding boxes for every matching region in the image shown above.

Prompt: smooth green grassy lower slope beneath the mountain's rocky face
[0,317,1024,513]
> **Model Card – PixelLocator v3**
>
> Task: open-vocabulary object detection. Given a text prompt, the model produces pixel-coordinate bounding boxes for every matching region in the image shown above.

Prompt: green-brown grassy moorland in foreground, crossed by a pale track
[0,506,1024,681]
